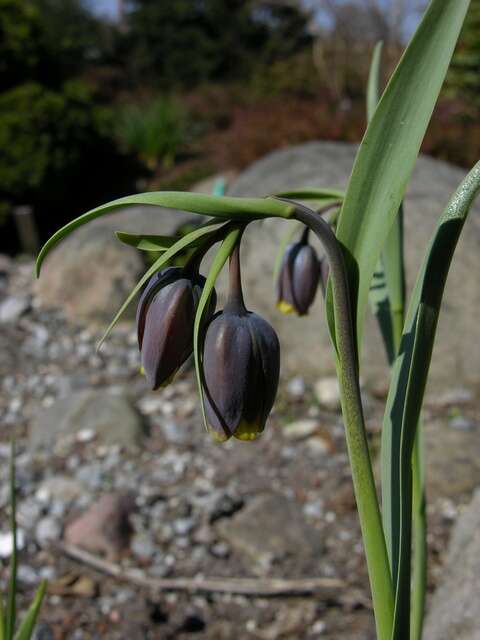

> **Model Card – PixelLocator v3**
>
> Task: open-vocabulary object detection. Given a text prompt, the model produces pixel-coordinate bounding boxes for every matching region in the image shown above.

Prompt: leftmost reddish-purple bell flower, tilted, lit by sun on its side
[137,267,215,389]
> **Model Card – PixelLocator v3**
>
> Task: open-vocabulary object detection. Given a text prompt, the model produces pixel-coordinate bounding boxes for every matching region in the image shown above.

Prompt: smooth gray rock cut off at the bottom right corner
[425,491,480,640]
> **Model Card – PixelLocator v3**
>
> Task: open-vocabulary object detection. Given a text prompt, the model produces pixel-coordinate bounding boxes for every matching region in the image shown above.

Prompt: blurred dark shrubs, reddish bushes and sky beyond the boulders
[0,0,480,255]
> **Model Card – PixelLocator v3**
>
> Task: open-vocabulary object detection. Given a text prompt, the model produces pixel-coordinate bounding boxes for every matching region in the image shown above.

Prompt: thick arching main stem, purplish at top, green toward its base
[288,204,394,640]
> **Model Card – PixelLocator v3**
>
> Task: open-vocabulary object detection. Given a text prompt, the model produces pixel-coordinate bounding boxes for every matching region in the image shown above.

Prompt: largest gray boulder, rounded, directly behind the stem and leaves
[228,142,480,391]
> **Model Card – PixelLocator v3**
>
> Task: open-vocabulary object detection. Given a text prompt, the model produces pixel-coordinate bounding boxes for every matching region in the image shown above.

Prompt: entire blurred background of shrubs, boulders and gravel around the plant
[0,5,480,640]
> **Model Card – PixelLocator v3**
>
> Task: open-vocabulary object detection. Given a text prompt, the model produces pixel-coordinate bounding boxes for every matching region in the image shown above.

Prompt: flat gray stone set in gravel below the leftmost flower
[29,390,144,450]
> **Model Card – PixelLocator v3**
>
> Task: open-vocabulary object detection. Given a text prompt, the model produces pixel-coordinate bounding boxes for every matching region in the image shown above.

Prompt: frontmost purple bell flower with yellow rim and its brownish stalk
[203,246,280,442]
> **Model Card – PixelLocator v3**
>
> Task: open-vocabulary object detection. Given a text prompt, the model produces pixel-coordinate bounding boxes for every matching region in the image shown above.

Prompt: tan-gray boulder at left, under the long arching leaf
[35,203,200,325]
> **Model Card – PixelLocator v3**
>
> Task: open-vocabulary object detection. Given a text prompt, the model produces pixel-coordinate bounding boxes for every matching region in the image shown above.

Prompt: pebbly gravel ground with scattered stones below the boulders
[0,259,480,640]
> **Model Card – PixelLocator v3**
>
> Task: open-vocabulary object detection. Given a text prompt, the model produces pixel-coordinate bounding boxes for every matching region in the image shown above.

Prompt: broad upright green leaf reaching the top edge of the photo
[327,0,469,352]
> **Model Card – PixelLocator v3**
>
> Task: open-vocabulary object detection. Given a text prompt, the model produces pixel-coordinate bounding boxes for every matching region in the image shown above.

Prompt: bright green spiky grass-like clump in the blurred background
[118,97,188,169]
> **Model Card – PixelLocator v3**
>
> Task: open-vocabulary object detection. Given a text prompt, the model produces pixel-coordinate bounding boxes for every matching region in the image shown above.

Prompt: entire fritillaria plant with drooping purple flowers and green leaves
[37,0,480,640]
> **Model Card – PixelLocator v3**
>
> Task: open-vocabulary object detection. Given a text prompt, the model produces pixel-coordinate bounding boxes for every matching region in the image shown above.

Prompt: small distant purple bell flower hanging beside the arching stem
[277,228,320,316]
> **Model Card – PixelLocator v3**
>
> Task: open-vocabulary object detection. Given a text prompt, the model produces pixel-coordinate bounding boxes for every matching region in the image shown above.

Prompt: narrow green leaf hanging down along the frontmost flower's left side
[193,225,243,429]
